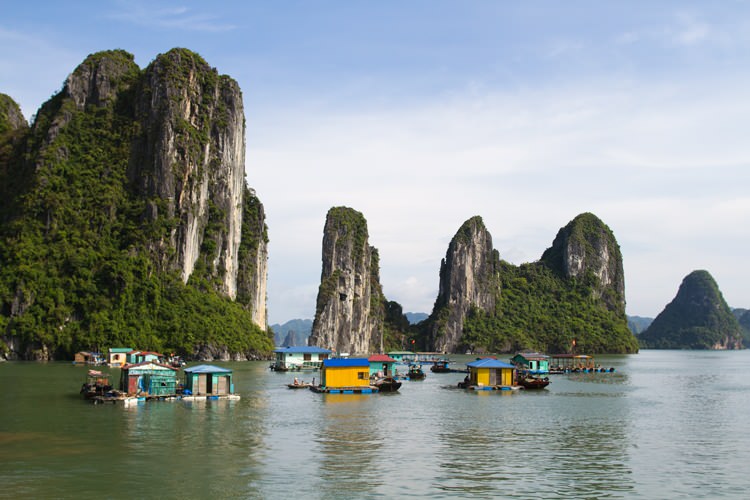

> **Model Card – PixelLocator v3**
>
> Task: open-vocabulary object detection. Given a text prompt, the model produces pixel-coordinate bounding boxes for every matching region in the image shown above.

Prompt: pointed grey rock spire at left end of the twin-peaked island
[430,216,500,352]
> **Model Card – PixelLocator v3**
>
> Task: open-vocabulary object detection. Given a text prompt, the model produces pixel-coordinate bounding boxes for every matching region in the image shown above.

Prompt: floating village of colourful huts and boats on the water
[74,347,614,405]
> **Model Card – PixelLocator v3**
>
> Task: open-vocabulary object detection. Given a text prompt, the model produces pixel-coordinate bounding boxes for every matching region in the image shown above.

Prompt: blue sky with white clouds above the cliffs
[0,0,750,324]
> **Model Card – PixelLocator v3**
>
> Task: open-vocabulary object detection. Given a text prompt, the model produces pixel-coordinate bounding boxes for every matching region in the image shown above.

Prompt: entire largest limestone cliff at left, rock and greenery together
[0,49,272,359]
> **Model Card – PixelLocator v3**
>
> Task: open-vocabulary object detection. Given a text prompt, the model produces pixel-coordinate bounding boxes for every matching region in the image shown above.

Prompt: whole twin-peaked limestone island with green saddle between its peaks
[421,214,638,353]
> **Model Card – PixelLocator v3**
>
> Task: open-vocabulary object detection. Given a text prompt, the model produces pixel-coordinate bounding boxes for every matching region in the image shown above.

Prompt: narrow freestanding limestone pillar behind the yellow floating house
[309,207,384,354]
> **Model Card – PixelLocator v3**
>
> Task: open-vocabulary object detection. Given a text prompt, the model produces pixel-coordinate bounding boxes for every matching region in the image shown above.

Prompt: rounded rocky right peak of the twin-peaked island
[542,213,625,314]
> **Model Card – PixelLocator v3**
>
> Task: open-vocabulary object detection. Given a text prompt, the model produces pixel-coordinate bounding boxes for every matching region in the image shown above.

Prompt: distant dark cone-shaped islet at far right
[639,270,743,349]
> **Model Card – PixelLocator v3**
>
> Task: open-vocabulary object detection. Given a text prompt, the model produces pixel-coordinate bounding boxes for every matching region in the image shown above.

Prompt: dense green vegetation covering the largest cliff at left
[0,51,273,359]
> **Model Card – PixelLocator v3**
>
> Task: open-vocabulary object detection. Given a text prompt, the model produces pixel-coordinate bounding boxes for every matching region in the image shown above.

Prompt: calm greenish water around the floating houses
[0,351,750,499]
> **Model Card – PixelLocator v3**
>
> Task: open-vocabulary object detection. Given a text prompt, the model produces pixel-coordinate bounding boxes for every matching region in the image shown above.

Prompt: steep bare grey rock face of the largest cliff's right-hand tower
[129,49,245,298]
